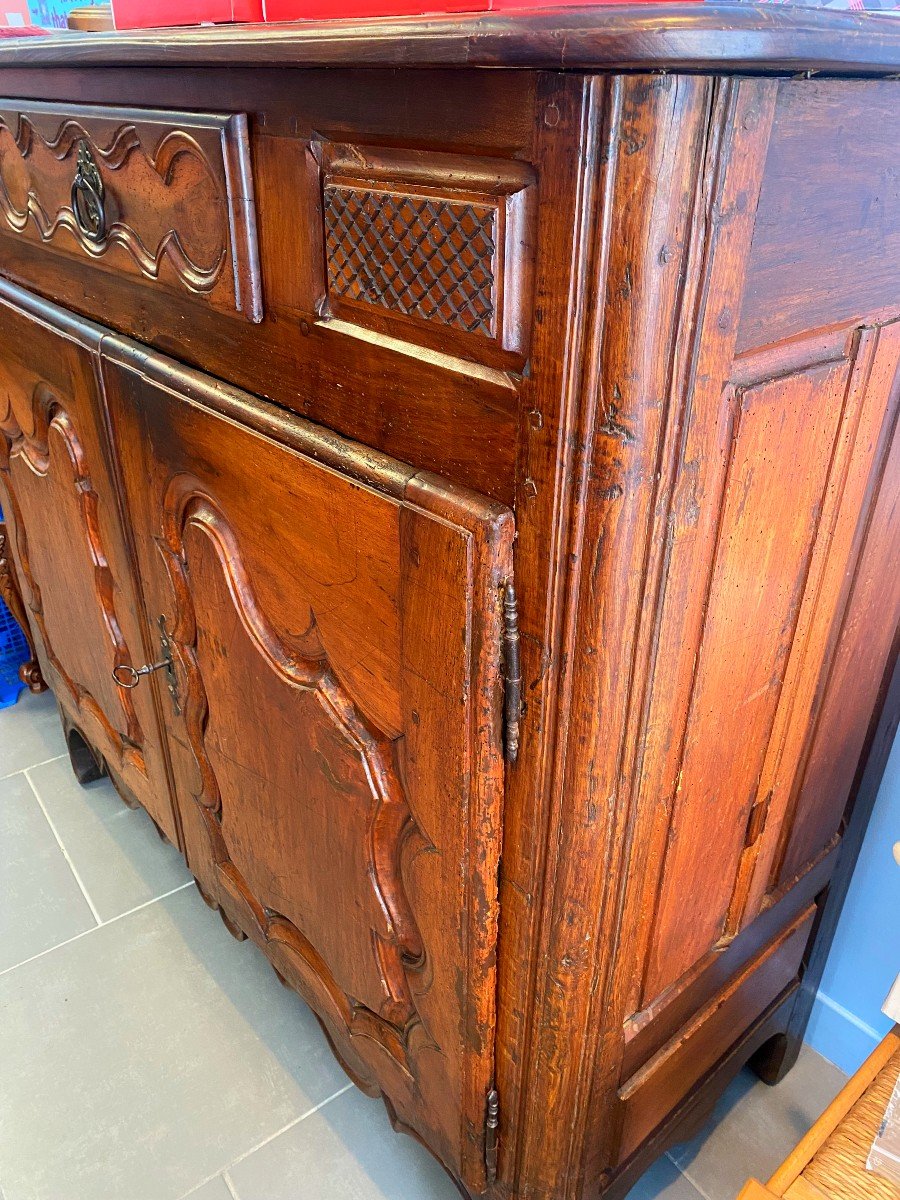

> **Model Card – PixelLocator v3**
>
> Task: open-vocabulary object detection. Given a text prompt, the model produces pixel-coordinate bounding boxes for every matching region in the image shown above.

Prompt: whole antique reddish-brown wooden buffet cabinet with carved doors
[0,5,900,1200]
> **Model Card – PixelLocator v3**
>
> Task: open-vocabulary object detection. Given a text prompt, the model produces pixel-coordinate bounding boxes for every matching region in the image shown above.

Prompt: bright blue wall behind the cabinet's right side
[806,736,900,1074]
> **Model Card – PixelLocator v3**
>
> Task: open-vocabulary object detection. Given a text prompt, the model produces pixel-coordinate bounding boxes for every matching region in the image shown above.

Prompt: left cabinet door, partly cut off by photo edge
[0,284,179,844]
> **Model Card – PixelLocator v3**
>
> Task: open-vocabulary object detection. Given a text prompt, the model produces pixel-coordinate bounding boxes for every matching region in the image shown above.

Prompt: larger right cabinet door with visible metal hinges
[103,338,512,1189]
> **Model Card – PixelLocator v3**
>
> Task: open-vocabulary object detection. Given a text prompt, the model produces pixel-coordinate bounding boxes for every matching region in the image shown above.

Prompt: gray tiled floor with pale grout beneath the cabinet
[0,696,844,1200]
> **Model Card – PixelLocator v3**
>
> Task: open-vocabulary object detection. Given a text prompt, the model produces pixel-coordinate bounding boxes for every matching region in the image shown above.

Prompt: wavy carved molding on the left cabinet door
[0,383,146,774]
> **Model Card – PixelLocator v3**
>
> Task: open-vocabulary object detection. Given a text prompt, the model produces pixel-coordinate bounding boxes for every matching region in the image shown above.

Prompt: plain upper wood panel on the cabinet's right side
[738,80,900,350]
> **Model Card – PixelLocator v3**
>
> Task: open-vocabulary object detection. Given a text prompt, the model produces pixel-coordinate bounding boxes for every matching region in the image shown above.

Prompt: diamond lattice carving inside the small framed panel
[325,186,497,337]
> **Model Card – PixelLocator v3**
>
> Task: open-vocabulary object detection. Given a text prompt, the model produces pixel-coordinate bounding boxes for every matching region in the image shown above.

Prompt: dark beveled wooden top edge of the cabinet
[0,4,900,76]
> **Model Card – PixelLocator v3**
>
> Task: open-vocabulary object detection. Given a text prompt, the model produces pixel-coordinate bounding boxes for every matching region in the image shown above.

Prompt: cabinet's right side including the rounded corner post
[508,77,900,1200]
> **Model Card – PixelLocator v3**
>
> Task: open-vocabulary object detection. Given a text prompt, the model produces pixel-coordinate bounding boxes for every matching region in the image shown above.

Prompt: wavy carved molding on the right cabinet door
[161,475,427,1073]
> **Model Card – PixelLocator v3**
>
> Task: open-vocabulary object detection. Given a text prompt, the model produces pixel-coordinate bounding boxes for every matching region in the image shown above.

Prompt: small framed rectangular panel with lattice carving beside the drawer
[313,142,534,358]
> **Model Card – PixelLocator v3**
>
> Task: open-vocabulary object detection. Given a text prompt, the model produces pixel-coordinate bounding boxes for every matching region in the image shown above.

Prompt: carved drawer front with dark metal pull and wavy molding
[0,100,262,322]
